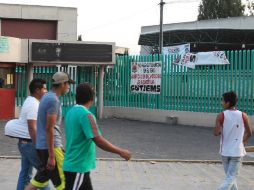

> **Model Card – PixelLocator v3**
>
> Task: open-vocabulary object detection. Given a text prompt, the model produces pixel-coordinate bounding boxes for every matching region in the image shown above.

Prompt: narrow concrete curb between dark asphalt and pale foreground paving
[0,156,254,166]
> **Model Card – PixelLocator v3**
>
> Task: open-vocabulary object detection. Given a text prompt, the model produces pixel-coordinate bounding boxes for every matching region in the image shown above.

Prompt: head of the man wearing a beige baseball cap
[52,71,75,96]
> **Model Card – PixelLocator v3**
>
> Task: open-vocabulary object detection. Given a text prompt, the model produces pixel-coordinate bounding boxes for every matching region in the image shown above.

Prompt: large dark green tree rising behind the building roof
[198,0,245,20]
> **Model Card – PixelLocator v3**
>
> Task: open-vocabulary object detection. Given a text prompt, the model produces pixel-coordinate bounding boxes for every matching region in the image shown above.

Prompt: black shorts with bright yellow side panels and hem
[31,147,65,190]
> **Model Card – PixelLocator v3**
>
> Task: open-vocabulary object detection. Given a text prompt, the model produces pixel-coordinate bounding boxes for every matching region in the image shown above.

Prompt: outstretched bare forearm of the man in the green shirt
[93,136,131,160]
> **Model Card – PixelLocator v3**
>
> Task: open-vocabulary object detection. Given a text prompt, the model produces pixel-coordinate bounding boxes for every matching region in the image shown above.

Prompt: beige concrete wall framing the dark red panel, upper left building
[0,3,78,41]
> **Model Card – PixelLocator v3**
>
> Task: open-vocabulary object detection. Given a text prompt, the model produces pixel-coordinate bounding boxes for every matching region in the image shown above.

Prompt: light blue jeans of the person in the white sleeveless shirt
[218,156,242,190]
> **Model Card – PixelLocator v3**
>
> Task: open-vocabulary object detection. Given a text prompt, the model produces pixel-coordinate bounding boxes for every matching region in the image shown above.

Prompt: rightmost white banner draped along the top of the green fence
[177,51,229,68]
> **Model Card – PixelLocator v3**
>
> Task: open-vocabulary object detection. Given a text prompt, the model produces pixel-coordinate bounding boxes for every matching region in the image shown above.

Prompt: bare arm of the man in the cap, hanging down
[46,114,57,170]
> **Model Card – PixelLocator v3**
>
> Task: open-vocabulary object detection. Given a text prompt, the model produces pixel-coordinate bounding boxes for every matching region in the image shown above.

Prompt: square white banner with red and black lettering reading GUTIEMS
[130,61,162,94]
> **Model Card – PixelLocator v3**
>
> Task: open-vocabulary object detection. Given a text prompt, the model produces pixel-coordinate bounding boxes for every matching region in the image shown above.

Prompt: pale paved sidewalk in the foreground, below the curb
[0,159,254,190]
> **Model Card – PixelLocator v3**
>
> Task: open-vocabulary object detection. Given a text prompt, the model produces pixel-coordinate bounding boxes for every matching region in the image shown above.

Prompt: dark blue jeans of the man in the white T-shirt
[17,140,50,190]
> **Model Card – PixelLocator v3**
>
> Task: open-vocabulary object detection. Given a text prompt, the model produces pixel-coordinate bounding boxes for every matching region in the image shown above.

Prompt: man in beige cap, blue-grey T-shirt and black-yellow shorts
[26,72,75,190]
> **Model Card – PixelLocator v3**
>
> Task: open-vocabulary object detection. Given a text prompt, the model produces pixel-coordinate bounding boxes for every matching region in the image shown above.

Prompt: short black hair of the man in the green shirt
[76,83,94,105]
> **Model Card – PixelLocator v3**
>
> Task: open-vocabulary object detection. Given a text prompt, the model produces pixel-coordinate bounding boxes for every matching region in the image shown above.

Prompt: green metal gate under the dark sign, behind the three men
[15,65,97,116]
